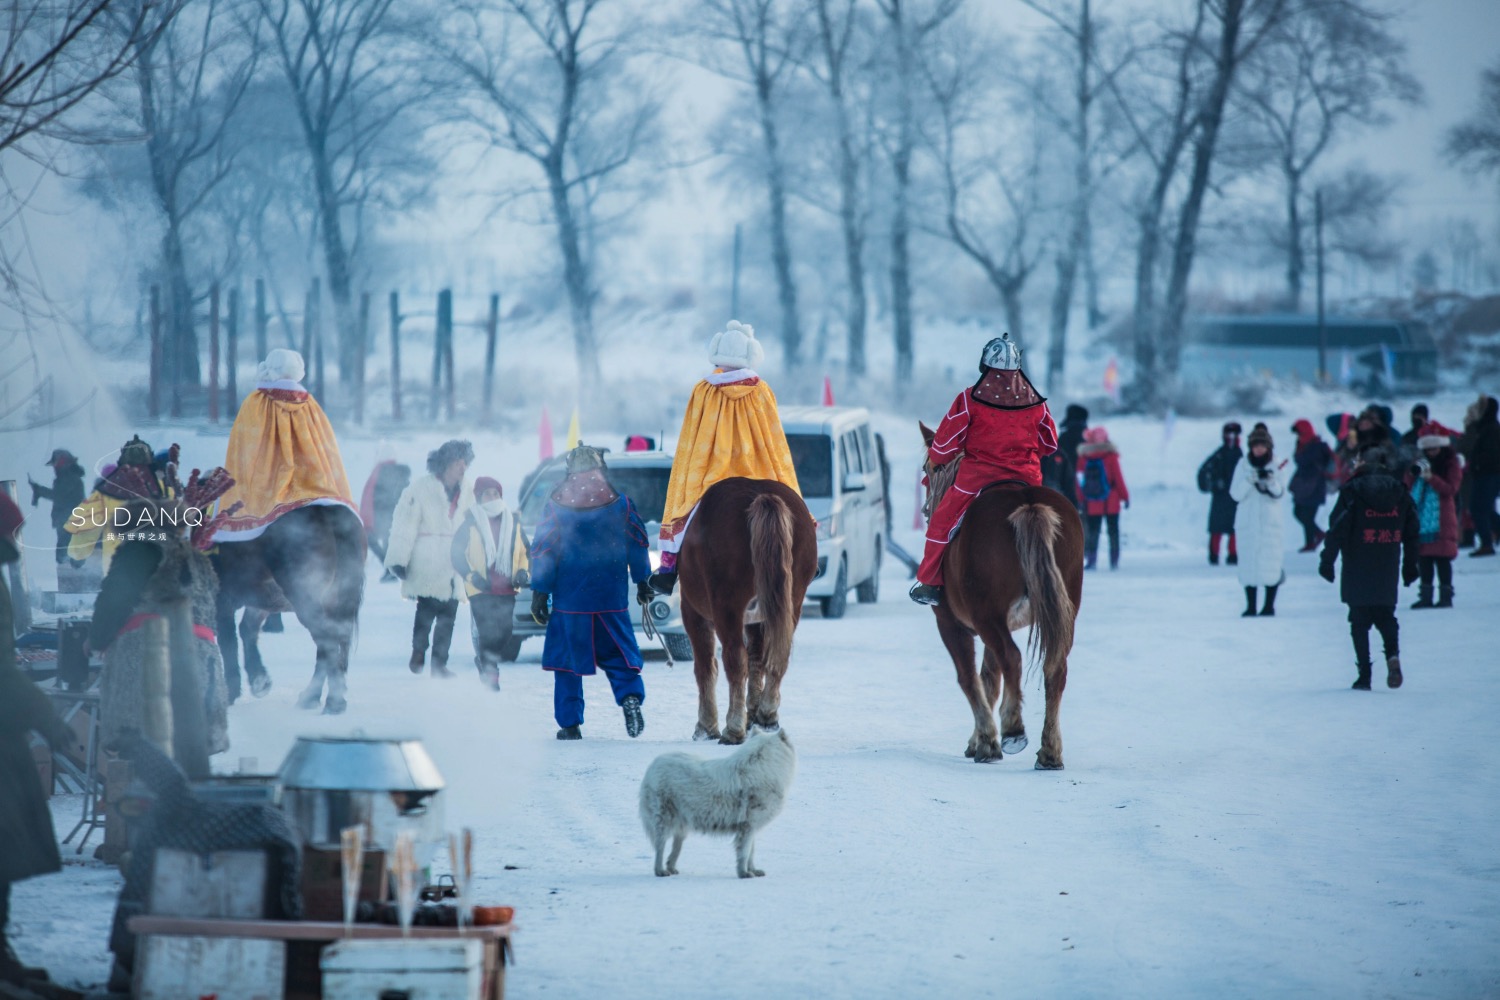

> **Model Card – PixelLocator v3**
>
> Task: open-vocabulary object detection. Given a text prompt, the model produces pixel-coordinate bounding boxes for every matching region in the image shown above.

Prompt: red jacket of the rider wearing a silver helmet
[927,388,1058,486]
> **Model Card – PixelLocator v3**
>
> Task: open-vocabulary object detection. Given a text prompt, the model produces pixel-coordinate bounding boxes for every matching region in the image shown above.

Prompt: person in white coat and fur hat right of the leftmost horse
[386,441,474,678]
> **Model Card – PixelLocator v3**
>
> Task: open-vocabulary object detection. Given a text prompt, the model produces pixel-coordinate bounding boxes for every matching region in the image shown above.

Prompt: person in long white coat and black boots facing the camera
[1229,424,1287,618]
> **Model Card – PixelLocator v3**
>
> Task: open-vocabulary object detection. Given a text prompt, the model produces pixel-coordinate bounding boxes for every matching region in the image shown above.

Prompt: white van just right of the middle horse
[782,406,888,618]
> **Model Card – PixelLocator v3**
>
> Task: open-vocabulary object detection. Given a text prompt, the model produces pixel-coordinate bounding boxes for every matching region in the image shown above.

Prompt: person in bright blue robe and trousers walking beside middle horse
[531,445,651,739]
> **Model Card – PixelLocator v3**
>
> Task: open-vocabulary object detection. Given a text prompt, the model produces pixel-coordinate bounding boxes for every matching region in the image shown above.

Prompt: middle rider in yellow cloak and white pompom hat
[651,321,801,594]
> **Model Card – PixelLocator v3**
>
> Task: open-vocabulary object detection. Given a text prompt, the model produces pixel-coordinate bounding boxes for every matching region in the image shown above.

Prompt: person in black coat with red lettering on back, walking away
[1319,445,1421,691]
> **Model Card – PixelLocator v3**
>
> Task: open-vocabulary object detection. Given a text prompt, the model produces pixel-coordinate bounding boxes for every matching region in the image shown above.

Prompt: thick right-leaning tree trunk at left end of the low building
[1161,0,1245,403]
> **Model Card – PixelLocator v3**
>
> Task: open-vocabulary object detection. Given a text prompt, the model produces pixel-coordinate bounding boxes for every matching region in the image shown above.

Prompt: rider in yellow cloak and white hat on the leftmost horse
[216,348,359,543]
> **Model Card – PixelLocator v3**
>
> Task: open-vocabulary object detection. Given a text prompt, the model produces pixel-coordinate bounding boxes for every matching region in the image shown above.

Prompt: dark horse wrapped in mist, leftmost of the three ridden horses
[213,505,365,715]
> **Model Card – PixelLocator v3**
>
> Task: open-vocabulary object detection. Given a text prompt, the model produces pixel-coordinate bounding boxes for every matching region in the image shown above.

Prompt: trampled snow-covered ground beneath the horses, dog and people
[12,400,1500,999]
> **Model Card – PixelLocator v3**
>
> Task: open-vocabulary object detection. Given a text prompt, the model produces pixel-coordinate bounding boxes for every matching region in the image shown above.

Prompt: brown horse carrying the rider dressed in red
[921,424,1083,771]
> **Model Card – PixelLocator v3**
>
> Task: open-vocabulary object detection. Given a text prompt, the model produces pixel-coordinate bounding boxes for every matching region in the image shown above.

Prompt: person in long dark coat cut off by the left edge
[0,493,78,996]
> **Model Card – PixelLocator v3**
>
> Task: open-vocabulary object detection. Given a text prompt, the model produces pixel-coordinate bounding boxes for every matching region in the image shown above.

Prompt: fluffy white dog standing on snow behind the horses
[641,729,797,879]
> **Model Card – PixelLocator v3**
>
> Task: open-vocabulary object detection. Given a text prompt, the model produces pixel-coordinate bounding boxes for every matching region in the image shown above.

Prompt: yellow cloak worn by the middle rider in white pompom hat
[662,376,803,538]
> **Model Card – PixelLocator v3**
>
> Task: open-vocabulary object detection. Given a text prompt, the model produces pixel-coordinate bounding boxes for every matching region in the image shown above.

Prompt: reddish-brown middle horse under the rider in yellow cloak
[677,477,818,744]
